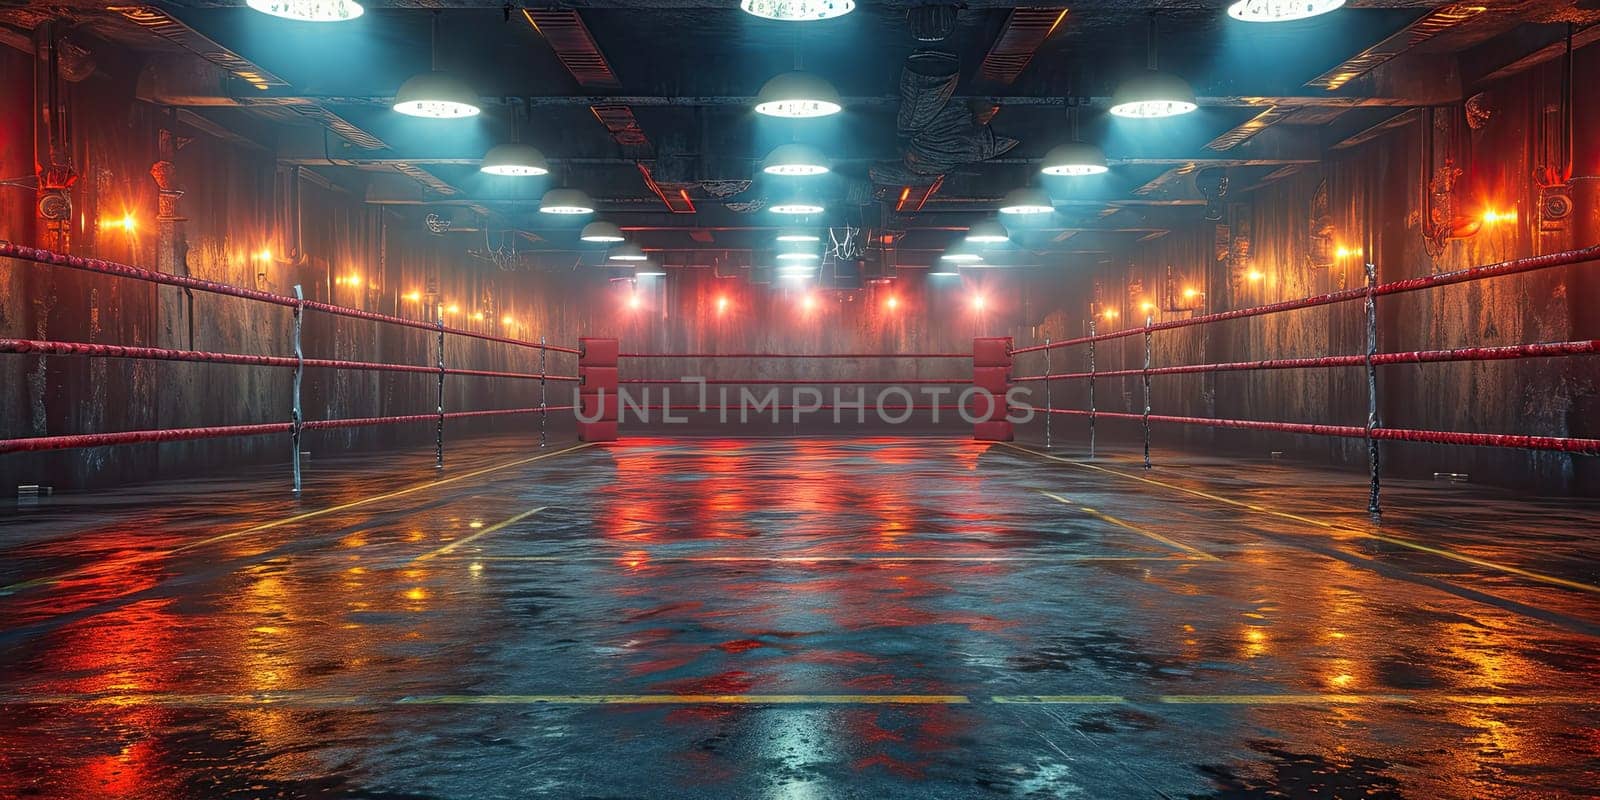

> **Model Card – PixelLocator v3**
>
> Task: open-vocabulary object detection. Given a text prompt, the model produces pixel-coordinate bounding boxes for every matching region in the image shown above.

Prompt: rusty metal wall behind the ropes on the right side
[1018,48,1600,494]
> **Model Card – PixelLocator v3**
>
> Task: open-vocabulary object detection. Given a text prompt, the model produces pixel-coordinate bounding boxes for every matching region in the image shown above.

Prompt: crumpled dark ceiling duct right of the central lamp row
[872,50,1016,186]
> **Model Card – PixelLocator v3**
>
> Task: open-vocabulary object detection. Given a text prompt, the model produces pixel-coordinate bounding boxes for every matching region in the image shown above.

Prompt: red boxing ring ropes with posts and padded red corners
[0,243,1600,514]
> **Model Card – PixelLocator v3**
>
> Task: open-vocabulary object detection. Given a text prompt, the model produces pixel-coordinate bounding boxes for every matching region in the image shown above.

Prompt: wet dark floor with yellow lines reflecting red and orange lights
[0,438,1600,798]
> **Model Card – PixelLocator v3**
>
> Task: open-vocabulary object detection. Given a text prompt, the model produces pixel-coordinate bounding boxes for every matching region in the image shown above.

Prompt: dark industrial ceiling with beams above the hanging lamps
[0,0,1593,264]
